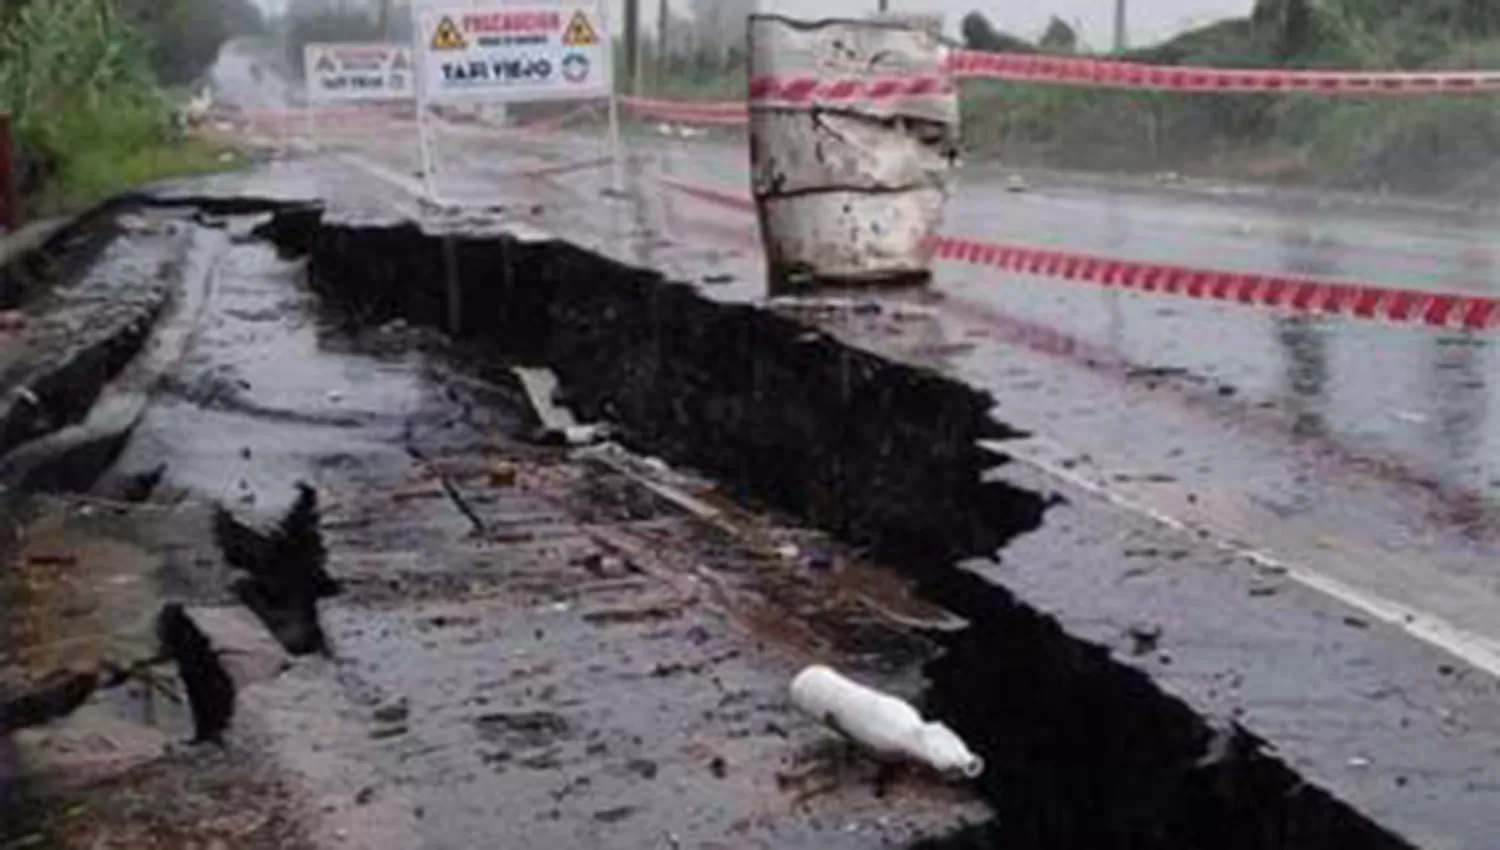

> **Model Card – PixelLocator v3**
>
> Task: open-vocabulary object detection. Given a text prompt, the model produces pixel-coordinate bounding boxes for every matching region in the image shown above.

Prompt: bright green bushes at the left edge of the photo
[0,0,255,213]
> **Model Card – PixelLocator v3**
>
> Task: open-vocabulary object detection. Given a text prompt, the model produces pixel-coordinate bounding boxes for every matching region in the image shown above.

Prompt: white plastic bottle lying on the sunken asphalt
[791,664,984,780]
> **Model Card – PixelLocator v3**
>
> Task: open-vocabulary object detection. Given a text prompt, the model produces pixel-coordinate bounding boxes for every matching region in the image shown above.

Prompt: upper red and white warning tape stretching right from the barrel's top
[950,49,1500,94]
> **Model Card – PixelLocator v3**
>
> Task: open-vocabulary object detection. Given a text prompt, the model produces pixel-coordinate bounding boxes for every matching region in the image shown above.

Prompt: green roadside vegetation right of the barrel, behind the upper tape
[963,0,1500,195]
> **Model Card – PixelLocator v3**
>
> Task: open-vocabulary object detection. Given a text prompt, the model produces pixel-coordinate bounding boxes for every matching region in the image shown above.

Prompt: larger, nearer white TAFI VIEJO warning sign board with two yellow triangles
[419,3,614,100]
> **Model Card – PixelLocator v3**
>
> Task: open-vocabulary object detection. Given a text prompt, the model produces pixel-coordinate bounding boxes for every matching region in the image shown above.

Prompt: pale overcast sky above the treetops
[257,0,1254,49]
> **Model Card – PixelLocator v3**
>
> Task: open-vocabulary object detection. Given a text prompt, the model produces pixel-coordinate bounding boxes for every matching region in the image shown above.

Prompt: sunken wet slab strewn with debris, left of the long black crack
[0,213,990,849]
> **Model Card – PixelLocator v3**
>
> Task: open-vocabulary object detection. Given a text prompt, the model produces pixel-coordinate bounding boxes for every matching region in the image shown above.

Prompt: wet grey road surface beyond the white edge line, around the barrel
[286,113,1500,672]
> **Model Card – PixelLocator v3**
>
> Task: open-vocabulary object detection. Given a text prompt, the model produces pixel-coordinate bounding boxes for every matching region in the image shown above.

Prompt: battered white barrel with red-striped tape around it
[750,15,959,294]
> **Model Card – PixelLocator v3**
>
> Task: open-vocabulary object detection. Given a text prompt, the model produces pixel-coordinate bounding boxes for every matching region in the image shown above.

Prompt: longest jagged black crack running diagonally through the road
[252,202,1434,850]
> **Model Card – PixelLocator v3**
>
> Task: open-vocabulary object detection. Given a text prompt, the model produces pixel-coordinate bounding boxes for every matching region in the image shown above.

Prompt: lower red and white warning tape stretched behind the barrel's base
[662,178,1500,331]
